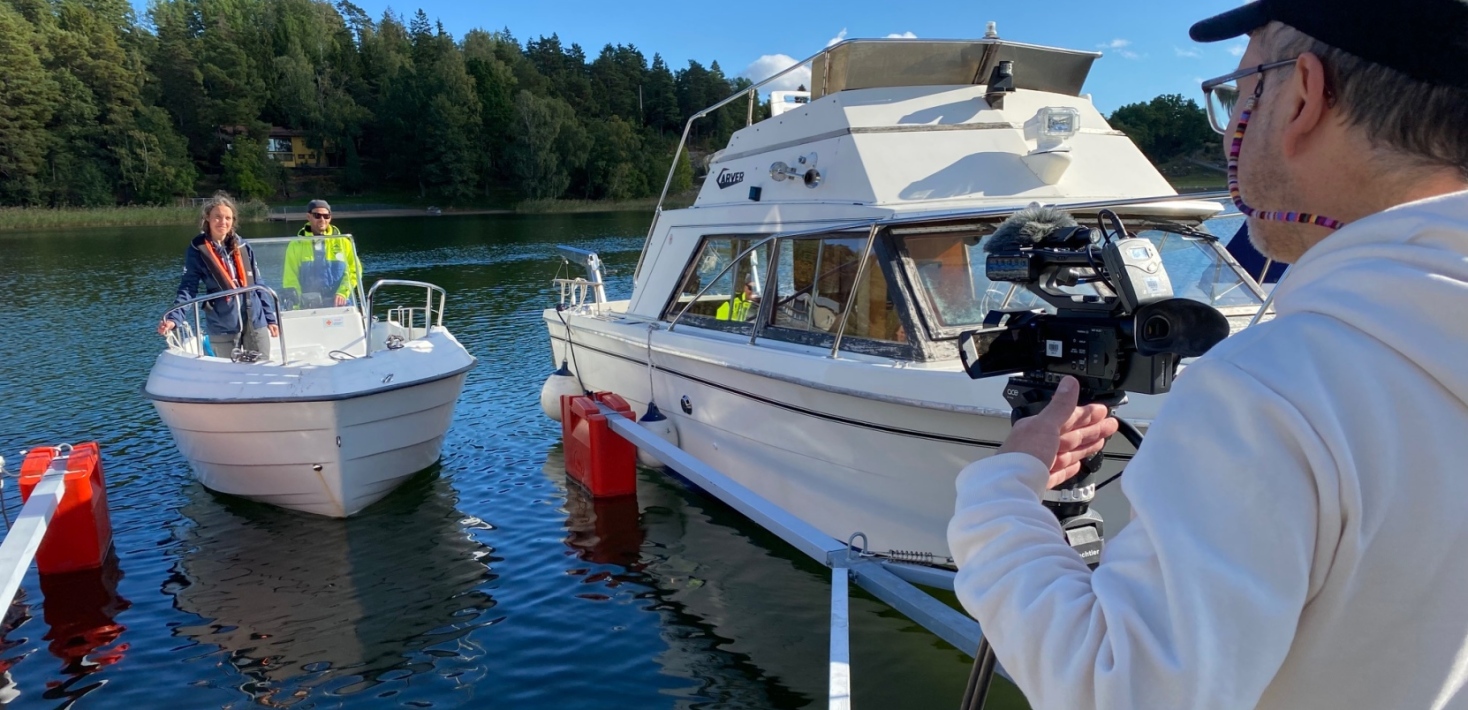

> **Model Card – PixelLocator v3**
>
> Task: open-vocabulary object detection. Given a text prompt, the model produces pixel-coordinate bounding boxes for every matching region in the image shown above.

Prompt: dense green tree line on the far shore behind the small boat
[0,0,768,207]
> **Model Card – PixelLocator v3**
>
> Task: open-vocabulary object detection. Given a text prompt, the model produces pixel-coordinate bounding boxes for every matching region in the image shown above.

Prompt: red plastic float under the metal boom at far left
[21,442,112,574]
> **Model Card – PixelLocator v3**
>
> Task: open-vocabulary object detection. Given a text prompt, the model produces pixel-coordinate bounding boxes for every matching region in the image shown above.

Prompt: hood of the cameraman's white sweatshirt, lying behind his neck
[1274,192,1468,402]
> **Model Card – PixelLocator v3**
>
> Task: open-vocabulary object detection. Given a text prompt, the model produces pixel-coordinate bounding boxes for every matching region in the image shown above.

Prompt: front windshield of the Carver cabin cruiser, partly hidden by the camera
[898,219,1264,329]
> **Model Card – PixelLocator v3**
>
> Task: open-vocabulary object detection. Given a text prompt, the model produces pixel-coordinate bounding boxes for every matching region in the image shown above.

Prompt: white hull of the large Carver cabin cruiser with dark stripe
[546,314,1154,563]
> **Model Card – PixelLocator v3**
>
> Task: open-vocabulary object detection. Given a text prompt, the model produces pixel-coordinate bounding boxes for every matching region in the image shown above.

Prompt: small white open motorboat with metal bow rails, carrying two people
[144,235,476,518]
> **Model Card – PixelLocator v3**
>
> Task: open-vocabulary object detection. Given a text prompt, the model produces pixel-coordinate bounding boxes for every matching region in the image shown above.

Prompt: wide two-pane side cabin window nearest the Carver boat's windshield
[768,235,907,343]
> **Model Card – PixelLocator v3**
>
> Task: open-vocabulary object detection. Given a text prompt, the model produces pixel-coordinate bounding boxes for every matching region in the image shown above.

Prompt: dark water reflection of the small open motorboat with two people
[163,469,495,706]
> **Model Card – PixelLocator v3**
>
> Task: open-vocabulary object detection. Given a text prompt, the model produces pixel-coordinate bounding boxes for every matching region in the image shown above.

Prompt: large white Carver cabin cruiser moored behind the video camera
[543,34,1264,565]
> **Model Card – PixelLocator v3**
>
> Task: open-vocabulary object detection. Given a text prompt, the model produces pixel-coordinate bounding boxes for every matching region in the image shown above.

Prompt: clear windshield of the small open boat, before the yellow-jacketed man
[248,235,361,311]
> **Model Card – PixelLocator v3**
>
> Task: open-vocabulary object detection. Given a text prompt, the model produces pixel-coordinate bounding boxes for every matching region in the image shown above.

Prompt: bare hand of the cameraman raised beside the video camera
[1000,377,1117,488]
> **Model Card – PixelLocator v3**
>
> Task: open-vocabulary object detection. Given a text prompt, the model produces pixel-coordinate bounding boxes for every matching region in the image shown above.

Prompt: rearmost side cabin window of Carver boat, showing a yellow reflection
[664,236,769,333]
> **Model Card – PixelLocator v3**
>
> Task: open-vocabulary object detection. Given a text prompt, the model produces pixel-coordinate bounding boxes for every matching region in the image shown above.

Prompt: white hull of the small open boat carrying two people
[153,373,465,518]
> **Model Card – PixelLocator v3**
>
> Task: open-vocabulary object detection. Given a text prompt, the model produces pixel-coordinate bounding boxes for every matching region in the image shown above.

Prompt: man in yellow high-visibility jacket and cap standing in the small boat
[280,200,361,308]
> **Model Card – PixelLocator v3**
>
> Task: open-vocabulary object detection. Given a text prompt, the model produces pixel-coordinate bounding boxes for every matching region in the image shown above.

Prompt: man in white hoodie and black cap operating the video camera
[948,0,1468,710]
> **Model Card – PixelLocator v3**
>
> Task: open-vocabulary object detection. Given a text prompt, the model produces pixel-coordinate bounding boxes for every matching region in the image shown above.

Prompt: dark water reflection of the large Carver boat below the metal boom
[543,447,980,707]
